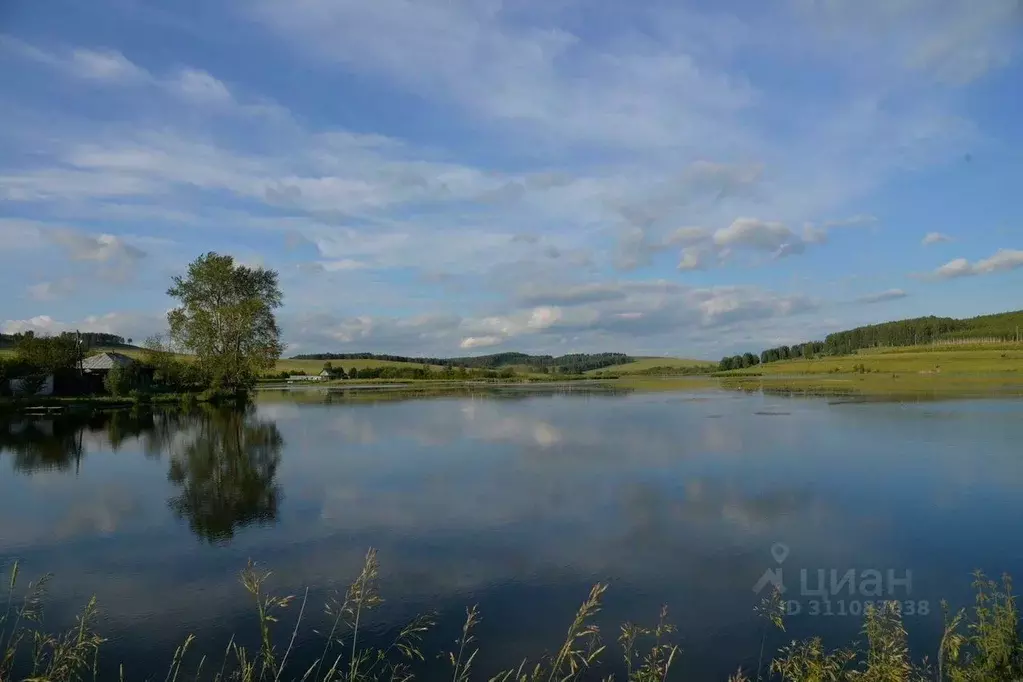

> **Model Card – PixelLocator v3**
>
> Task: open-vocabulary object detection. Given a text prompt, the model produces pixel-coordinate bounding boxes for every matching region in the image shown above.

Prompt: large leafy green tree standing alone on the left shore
[167,252,283,389]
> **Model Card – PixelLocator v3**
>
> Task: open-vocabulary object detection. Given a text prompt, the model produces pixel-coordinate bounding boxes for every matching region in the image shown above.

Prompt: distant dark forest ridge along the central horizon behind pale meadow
[293,353,632,374]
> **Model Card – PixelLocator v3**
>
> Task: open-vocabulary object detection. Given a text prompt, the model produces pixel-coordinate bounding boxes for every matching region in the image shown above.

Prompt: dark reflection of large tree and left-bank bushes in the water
[0,408,284,543]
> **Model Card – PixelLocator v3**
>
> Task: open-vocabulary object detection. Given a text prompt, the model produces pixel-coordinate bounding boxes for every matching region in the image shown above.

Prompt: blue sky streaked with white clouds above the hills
[0,0,1023,358]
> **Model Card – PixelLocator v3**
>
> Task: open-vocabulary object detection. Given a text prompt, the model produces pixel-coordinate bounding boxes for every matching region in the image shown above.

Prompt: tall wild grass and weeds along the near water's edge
[0,550,1023,682]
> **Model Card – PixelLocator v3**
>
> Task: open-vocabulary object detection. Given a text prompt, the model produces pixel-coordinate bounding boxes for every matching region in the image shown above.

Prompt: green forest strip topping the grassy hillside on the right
[719,311,1023,370]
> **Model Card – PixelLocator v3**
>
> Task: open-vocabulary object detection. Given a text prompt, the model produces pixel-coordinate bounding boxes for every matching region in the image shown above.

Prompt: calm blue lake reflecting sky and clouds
[0,390,1023,680]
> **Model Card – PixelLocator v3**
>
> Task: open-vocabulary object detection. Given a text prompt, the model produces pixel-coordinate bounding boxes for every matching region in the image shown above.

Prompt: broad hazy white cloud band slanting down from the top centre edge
[248,0,754,148]
